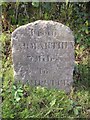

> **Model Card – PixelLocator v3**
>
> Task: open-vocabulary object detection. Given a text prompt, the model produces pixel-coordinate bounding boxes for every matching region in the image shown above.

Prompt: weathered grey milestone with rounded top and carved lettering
[12,20,74,91]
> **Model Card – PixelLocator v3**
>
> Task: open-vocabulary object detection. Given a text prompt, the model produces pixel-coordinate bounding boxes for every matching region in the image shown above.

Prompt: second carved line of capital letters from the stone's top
[20,42,74,49]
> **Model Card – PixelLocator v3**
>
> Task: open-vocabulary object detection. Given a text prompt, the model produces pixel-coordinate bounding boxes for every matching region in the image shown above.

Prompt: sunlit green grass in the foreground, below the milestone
[2,80,90,118]
